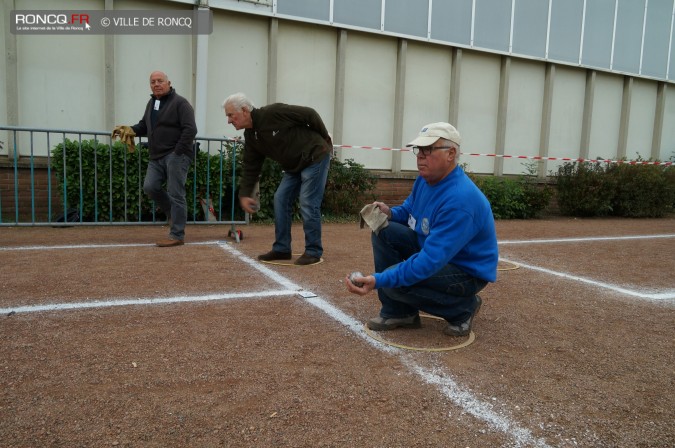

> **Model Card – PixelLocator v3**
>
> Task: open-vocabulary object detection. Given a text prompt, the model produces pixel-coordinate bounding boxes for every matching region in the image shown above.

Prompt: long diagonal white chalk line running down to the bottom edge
[218,243,549,448]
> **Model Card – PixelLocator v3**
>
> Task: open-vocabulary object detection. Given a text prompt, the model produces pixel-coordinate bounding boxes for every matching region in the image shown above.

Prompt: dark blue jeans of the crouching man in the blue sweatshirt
[371,222,487,325]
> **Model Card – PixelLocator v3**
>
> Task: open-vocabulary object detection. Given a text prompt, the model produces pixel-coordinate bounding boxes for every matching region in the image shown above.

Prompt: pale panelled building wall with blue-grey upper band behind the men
[0,0,675,175]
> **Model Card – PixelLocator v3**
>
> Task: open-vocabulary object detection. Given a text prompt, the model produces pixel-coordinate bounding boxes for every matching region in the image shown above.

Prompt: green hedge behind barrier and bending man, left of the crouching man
[51,140,376,222]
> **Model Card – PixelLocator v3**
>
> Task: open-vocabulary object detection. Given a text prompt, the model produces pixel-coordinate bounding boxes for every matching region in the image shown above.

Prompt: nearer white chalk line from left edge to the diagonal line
[0,289,298,315]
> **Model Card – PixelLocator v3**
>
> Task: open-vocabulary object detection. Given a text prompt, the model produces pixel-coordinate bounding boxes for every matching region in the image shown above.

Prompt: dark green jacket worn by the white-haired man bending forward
[239,103,333,197]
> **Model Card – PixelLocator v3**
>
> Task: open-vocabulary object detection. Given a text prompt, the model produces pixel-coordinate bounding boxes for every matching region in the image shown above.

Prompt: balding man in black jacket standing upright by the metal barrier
[113,71,197,247]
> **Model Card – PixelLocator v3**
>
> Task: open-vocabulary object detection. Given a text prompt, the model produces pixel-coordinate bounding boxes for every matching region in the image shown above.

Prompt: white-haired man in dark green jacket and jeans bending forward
[223,93,333,265]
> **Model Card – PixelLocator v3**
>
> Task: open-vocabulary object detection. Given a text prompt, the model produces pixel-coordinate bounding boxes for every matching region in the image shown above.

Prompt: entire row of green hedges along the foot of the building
[51,140,675,222]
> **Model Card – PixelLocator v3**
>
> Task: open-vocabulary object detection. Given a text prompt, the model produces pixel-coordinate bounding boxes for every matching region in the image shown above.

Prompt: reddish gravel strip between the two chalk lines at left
[2,241,280,307]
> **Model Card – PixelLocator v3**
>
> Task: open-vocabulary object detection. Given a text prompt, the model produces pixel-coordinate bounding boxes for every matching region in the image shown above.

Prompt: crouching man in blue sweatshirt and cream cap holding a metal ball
[345,123,498,336]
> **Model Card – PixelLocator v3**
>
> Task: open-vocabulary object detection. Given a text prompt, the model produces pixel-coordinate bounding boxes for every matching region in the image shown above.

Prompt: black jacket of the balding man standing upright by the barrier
[131,87,197,160]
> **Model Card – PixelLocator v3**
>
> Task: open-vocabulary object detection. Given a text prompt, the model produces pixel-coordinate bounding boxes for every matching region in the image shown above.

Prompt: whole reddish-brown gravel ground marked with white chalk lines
[0,218,675,447]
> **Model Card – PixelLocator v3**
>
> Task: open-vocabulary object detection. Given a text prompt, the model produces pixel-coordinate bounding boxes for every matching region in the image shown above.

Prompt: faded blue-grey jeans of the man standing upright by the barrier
[143,153,192,241]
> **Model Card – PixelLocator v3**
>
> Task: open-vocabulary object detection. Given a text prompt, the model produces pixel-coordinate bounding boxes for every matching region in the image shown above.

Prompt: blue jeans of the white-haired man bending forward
[272,157,330,258]
